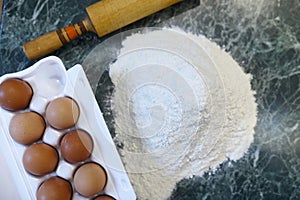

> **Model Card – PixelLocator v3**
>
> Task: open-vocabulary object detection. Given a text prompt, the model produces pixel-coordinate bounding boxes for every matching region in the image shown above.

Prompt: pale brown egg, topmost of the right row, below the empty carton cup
[46,97,79,129]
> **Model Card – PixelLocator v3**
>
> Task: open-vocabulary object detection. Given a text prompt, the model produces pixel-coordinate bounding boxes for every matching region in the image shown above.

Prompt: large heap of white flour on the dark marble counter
[110,29,256,200]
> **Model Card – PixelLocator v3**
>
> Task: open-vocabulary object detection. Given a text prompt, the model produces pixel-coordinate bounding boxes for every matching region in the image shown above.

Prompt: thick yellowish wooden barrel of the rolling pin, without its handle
[86,0,182,37]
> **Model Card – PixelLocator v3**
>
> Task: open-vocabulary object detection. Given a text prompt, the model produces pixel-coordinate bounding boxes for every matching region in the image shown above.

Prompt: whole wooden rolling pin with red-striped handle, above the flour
[23,0,182,60]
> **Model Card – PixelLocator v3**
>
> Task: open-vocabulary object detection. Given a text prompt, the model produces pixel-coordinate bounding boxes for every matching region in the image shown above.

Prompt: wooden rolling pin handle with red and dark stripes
[23,18,93,60]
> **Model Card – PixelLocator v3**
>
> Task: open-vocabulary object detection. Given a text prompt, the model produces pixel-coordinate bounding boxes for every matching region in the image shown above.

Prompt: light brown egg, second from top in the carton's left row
[9,112,46,144]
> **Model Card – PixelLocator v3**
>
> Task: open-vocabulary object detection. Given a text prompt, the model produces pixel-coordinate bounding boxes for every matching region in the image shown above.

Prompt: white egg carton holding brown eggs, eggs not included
[0,56,136,200]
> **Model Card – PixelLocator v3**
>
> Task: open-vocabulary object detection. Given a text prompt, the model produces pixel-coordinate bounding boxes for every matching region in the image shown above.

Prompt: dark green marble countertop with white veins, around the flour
[0,0,300,200]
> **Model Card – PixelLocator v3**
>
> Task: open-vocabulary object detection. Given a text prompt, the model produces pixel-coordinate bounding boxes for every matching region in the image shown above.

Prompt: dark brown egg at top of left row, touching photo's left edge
[0,78,33,111]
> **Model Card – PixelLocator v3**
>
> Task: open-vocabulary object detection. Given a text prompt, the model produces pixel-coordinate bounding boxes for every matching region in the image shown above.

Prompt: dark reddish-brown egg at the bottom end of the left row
[37,177,73,200]
